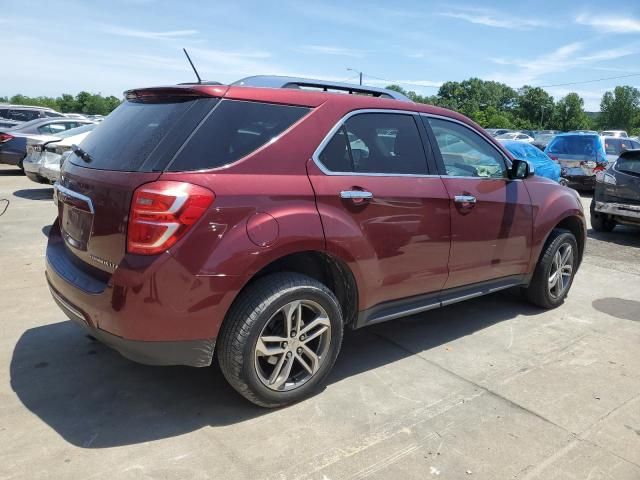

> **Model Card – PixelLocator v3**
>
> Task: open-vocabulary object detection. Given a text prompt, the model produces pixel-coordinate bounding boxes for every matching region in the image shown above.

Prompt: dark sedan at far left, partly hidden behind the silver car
[0,117,94,169]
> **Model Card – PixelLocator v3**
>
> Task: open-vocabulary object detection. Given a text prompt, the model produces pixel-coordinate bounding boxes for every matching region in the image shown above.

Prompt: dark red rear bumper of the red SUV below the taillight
[46,220,244,367]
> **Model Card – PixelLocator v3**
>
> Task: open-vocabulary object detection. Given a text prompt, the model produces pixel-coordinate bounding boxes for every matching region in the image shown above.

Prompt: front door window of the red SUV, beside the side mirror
[425,118,507,178]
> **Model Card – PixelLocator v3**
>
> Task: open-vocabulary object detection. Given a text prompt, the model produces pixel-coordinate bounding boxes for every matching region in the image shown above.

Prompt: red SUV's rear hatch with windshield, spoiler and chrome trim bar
[55,87,224,273]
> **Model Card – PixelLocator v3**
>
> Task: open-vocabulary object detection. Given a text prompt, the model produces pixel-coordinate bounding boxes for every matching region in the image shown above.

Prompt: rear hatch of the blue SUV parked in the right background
[545,135,606,176]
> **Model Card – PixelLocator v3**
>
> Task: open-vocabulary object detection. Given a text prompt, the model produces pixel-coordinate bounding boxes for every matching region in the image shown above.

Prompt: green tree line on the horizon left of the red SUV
[0,92,122,115]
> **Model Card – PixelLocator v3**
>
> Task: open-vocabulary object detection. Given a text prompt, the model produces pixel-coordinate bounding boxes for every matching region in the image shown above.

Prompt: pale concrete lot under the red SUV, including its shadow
[0,166,640,480]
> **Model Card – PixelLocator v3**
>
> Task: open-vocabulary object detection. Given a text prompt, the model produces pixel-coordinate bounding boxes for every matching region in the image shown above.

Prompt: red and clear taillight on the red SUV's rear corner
[127,181,215,255]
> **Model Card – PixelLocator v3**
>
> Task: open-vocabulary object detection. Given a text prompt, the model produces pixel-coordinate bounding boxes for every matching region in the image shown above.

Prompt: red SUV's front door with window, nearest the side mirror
[422,116,533,289]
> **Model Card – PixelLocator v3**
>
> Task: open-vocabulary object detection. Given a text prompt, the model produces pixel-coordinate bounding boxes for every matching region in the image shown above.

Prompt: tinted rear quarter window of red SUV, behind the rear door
[167,100,309,172]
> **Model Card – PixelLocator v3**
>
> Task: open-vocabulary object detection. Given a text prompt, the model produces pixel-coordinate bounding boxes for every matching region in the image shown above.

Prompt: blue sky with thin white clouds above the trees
[0,0,640,110]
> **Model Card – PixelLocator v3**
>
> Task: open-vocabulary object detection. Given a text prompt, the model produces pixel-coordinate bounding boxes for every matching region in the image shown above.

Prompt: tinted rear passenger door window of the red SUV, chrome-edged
[319,113,427,175]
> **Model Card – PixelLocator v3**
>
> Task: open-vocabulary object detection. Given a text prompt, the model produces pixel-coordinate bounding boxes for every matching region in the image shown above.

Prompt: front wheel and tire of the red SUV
[524,228,578,309]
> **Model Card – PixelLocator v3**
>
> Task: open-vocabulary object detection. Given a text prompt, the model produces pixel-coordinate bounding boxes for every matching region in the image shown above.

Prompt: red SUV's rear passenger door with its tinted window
[308,110,450,309]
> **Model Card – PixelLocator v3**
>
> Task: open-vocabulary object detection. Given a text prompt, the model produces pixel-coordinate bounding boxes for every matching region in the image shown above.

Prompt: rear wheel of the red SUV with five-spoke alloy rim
[216,272,343,408]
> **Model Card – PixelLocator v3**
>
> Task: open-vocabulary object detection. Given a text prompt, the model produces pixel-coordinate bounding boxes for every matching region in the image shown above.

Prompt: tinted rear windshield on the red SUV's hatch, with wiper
[69,97,218,172]
